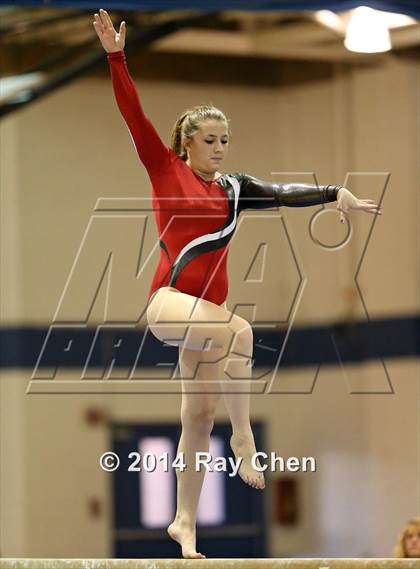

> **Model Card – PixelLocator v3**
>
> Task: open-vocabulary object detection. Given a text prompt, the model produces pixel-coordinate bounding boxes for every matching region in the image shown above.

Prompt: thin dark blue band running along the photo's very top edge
[0,0,420,18]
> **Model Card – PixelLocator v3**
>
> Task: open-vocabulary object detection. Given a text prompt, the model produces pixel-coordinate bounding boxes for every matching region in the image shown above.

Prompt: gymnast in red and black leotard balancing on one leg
[93,9,382,559]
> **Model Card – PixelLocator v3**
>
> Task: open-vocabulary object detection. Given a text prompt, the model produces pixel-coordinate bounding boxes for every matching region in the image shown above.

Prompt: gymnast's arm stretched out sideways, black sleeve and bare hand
[235,174,383,222]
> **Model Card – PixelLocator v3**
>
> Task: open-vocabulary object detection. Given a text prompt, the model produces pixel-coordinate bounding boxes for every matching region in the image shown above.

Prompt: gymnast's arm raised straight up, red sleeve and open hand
[94,10,170,172]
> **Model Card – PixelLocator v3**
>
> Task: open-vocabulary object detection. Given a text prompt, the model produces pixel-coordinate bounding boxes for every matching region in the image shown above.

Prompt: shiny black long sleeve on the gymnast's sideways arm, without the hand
[237,174,343,209]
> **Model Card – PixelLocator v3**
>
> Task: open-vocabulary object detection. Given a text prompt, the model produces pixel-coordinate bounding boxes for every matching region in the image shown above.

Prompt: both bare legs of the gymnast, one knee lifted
[147,287,264,558]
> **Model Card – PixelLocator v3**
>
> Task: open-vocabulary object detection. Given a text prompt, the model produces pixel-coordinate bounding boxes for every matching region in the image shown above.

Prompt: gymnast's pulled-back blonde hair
[171,105,230,160]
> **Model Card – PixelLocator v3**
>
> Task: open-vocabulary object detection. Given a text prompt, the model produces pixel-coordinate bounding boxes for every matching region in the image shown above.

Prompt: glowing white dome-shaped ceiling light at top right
[344,6,392,53]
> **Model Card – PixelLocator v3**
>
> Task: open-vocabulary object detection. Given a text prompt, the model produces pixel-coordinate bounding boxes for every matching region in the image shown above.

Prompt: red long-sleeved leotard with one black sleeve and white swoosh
[108,51,342,305]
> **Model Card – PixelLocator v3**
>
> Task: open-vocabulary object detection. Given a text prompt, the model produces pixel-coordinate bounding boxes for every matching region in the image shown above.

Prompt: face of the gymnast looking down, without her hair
[184,119,229,174]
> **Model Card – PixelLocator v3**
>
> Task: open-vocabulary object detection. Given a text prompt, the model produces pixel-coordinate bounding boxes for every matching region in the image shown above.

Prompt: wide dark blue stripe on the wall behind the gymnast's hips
[0,316,420,370]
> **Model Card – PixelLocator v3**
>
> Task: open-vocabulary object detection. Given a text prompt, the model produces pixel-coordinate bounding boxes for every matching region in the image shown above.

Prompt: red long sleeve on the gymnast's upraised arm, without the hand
[107,50,170,172]
